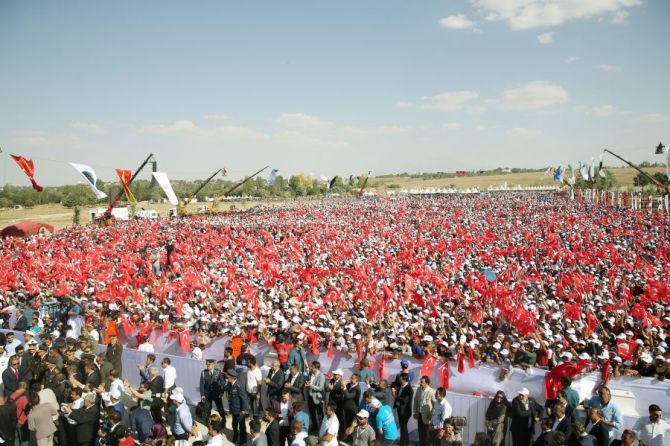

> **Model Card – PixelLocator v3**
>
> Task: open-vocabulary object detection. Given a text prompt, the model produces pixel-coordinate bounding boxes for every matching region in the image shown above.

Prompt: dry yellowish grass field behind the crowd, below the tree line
[0,167,665,229]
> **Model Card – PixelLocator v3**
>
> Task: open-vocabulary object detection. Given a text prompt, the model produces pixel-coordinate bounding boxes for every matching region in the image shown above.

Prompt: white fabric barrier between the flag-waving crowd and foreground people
[0,330,670,446]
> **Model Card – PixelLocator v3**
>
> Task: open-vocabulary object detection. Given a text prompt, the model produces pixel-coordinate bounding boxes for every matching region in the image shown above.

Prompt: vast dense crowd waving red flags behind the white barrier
[0,193,670,446]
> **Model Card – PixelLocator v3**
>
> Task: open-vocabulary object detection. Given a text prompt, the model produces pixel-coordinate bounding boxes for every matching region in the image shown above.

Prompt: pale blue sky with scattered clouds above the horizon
[0,0,670,185]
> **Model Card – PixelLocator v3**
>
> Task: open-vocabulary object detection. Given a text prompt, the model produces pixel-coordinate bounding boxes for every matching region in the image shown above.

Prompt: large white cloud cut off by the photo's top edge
[470,0,642,30]
